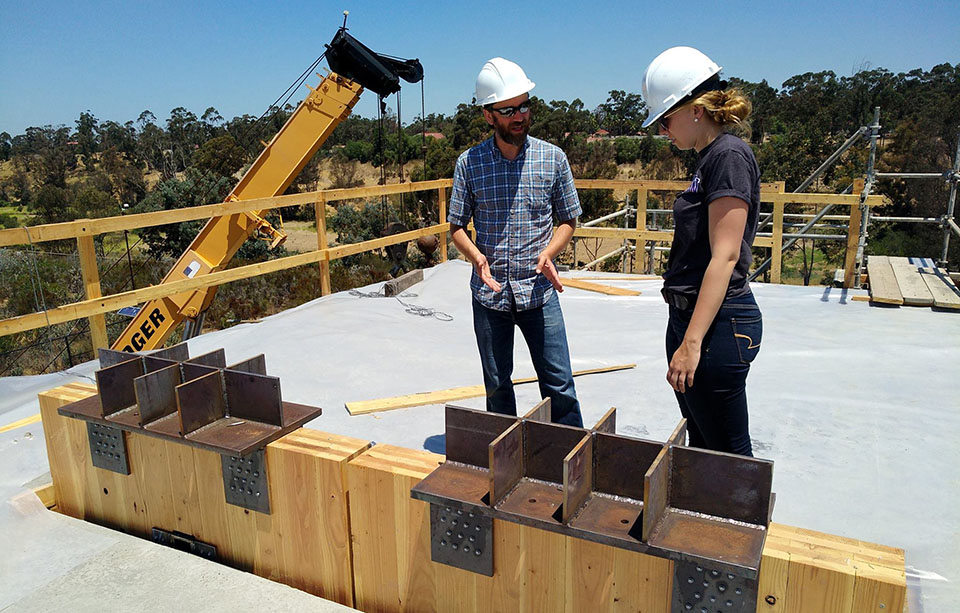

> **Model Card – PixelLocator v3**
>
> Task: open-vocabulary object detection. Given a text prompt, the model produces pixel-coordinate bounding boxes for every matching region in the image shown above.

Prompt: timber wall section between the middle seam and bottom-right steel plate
[348,445,673,612]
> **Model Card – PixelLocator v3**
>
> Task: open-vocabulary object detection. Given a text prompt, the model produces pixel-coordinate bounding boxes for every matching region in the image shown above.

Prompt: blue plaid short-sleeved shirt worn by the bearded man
[447,137,582,311]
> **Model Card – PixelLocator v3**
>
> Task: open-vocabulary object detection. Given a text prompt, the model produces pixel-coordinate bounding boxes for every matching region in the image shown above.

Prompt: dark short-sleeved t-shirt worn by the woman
[663,132,760,298]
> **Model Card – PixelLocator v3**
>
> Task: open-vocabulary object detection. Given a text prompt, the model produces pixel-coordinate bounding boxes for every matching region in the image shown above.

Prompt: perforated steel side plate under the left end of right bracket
[430,504,493,577]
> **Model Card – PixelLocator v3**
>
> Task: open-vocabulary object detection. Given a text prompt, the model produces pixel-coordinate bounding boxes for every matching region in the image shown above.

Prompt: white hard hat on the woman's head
[641,47,720,128]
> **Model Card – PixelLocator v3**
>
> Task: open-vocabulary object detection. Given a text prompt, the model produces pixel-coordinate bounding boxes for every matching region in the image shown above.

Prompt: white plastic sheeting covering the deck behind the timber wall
[0,261,960,611]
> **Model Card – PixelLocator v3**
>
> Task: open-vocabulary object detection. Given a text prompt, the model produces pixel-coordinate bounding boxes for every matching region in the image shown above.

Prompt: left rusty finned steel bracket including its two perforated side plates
[58,344,322,514]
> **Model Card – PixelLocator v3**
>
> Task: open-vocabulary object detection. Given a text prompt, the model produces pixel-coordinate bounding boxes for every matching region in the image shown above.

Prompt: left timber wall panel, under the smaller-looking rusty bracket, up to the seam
[40,384,370,606]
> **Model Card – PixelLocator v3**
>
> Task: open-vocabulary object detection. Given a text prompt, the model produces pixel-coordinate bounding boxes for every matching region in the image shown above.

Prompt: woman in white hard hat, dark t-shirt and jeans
[642,47,763,456]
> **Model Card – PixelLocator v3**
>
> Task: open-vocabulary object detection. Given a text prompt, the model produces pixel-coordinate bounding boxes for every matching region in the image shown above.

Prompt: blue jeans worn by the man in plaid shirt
[473,293,583,427]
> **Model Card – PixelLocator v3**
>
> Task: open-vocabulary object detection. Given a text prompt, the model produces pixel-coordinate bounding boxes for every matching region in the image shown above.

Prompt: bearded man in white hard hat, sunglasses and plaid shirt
[447,57,583,426]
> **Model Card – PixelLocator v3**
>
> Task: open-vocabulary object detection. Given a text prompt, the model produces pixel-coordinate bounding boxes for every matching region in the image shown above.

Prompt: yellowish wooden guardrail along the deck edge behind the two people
[0,179,883,348]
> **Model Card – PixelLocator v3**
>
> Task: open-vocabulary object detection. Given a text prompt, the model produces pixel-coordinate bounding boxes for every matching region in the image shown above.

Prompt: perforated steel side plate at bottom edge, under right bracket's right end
[671,561,758,613]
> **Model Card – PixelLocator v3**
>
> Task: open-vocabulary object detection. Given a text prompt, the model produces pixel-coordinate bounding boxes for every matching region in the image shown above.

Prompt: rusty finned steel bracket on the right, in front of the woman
[411,401,773,580]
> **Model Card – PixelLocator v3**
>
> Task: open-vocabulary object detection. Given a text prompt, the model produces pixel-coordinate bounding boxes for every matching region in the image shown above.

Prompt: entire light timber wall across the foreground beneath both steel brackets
[40,384,906,613]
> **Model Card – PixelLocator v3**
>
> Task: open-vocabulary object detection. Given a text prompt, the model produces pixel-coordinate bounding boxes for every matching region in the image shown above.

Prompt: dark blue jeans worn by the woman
[666,294,763,456]
